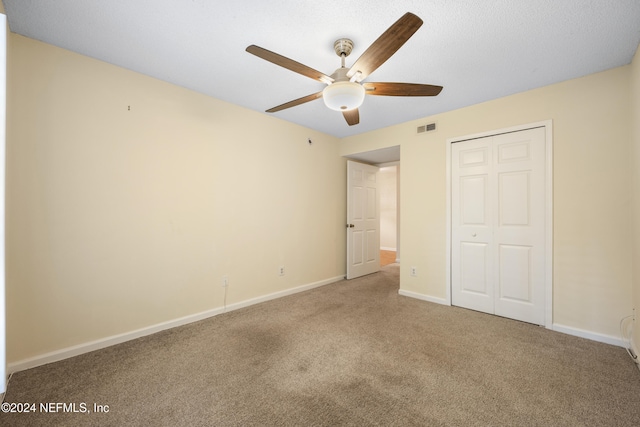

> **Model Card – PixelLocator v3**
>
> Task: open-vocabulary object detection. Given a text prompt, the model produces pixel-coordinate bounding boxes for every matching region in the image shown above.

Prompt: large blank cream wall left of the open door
[7,34,346,363]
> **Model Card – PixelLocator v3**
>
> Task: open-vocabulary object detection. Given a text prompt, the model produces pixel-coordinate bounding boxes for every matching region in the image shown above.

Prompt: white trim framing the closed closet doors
[445,120,553,329]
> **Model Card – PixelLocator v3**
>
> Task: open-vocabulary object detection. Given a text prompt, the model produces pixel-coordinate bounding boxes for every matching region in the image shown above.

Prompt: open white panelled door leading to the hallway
[347,161,380,279]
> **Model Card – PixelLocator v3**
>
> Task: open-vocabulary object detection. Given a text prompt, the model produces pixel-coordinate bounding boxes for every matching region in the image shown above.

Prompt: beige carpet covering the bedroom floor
[0,264,640,426]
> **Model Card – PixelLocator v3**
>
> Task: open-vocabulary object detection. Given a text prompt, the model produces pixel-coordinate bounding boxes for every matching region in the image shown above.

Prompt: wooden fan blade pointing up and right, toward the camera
[347,12,422,81]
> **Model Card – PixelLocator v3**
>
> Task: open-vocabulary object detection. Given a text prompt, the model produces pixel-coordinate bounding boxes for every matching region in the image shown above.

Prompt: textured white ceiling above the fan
[4,0,640,137]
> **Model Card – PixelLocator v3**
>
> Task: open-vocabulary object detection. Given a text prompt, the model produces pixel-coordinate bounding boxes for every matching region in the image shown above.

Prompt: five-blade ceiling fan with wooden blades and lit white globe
[246,12,442,126]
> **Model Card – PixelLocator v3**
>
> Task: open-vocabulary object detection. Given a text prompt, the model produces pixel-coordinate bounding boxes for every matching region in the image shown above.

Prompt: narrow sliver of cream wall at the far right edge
[631,47,640,354]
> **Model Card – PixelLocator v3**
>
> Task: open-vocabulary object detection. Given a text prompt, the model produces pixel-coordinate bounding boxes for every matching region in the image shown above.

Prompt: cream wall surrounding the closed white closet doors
[341,66,632,337]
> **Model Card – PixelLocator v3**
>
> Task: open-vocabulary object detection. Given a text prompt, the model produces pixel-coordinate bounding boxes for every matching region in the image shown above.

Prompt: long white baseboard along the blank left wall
[7,276,344,374]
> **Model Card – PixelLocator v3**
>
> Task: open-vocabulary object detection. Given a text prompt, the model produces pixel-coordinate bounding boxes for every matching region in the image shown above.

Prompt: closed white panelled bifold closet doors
[451,128,546,325]
